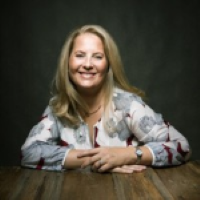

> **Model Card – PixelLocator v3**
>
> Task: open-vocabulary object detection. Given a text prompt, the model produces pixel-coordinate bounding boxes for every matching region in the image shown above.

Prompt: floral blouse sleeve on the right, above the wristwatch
[127,101,190,167]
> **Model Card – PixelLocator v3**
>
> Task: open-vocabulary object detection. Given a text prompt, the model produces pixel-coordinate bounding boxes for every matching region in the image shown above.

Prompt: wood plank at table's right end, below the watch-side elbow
[154,163,200,200]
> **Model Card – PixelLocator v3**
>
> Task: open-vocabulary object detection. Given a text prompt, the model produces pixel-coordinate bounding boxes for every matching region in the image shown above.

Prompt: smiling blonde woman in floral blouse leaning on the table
[21,25,190,173]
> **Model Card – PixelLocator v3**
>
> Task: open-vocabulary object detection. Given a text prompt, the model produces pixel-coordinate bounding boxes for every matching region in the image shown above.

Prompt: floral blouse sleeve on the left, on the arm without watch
[21,106,69,171]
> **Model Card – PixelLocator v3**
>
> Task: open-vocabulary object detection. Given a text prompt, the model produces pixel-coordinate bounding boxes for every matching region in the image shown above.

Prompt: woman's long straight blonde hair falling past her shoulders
[50,25,143,125]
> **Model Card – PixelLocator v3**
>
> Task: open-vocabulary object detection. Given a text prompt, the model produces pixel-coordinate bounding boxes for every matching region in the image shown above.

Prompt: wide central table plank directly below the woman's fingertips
[60,170,117,200]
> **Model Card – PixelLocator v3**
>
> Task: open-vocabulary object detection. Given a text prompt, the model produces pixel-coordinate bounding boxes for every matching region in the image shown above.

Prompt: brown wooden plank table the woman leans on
[0,160,200,200]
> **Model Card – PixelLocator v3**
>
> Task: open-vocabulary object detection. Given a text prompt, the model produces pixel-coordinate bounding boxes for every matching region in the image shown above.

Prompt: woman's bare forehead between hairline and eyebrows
[73,33,104,49]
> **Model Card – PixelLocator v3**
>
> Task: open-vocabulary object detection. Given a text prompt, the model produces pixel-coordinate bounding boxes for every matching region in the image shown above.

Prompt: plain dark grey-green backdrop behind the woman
[0,0,200,165]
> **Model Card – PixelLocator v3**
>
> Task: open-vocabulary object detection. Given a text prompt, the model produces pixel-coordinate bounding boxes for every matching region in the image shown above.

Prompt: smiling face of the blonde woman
[69,33,108,92]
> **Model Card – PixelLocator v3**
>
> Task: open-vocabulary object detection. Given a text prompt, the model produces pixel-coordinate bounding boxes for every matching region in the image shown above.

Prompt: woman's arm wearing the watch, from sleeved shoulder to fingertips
[78,94,190,171]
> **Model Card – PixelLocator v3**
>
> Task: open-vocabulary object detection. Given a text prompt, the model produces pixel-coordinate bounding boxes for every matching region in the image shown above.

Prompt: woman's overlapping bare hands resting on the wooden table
[77,147,146,173]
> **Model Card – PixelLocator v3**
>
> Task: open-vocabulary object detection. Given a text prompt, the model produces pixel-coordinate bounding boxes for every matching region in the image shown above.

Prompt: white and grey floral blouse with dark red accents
[21,88,189,171]
